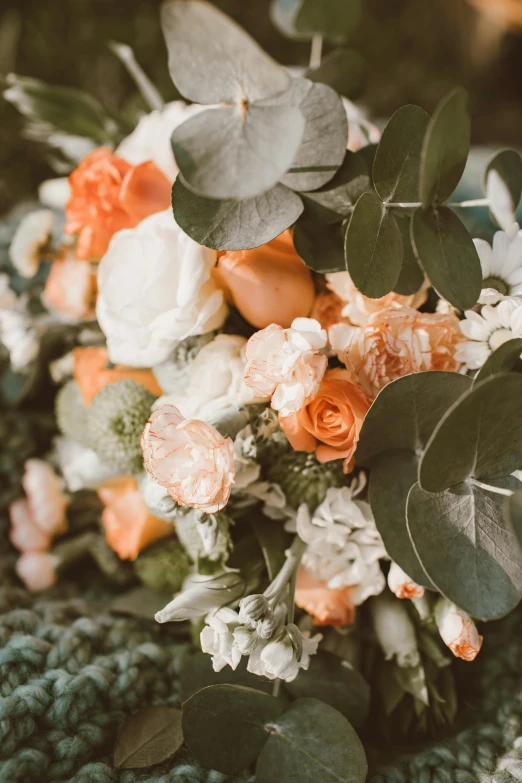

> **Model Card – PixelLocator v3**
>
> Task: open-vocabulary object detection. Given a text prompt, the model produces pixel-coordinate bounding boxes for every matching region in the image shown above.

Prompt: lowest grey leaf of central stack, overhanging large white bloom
[172,176,303,250]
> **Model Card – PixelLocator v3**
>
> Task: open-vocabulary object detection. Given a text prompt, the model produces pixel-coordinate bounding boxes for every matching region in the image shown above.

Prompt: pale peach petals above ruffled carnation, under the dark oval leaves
[326,272,429,326]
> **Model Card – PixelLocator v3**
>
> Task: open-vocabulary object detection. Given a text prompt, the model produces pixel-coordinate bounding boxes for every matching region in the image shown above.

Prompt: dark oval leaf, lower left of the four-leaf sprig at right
[345,193,402,299]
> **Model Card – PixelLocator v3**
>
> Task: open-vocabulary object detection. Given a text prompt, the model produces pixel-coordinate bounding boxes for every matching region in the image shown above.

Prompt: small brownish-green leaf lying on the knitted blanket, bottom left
[114,705,183,769]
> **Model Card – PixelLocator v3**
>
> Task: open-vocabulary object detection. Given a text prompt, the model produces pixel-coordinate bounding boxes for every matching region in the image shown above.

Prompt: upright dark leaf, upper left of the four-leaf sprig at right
[373,105,429,207]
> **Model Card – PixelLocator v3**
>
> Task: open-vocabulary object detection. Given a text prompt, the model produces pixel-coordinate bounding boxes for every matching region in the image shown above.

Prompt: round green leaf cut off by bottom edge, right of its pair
[256,699,368,783]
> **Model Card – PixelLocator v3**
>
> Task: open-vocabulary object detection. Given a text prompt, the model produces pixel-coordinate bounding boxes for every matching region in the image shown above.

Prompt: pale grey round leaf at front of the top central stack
[172,103,305,199]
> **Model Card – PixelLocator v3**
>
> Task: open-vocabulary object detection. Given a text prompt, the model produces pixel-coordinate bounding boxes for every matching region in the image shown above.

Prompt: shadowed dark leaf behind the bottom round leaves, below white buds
[285,650,370,728]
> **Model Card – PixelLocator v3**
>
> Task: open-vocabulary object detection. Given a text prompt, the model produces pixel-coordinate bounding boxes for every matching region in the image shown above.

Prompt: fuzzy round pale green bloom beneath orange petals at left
[88,380,156,472]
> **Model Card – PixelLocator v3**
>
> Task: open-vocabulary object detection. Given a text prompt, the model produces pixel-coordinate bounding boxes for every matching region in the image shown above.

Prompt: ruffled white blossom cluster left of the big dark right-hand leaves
[297,487,387,606]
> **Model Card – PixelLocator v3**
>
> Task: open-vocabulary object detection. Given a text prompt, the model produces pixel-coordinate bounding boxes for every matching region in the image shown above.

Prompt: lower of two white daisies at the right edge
[455,297,522,370]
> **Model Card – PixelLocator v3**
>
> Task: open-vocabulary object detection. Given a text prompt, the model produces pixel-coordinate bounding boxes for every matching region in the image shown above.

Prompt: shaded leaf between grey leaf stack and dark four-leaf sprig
[300,150,371,223]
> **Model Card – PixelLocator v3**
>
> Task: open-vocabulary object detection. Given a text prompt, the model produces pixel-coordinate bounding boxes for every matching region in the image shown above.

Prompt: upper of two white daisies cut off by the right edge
[473,223,522,305]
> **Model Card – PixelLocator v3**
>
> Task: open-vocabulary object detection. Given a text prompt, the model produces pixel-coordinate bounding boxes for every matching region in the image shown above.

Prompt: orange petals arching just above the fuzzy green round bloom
[73,346,162,405]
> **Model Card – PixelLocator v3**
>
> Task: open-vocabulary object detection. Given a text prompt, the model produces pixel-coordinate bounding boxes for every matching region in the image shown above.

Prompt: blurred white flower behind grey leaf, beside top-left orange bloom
[116,101,208,182]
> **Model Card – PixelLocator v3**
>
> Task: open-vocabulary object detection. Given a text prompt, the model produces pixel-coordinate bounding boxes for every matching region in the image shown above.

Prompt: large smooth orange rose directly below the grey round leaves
[213,229,315,329]
